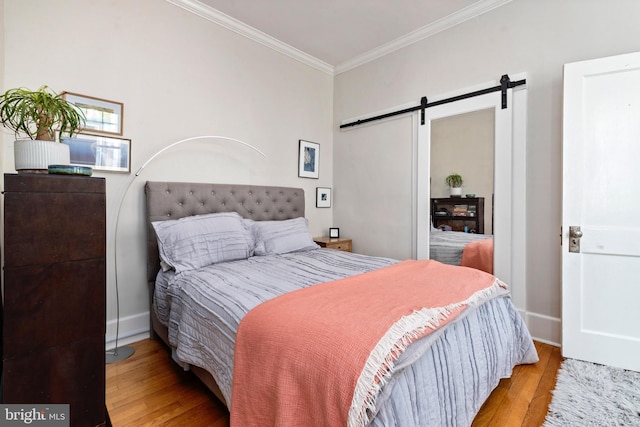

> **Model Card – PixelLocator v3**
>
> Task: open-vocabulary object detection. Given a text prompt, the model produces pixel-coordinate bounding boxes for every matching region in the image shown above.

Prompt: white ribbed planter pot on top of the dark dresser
[13,139,71,173]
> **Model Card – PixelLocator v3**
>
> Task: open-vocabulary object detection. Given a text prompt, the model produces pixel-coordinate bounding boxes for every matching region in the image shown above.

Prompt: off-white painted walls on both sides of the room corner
[6,0,640,348]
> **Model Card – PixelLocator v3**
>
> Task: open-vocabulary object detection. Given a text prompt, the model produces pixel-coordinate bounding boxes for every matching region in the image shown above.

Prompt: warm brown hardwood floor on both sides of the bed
[106,340,562,427]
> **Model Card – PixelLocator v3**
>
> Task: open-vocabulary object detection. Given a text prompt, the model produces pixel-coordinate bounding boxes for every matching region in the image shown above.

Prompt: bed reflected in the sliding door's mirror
[429,227,493,273]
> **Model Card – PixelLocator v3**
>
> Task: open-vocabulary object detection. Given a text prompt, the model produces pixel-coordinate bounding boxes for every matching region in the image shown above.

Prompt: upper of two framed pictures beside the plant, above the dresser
[62,92,124,135]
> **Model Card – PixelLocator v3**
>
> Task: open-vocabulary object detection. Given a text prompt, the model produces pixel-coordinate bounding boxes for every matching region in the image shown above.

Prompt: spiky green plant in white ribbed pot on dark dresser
[0,86,86,173]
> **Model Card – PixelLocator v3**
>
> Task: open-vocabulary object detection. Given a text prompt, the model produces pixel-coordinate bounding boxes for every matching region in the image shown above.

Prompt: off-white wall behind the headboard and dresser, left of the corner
[0,0,333,348]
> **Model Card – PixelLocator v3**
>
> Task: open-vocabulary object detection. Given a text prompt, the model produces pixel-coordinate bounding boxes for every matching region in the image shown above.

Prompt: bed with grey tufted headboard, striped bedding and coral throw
[145,182,537,427]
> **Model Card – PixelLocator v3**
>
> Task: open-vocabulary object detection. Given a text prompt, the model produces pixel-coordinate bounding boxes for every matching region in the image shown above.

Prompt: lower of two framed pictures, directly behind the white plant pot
[62,133,131,172]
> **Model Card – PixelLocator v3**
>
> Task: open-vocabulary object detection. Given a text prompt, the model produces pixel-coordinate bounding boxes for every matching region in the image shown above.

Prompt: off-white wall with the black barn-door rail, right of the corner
[334,0,640,343]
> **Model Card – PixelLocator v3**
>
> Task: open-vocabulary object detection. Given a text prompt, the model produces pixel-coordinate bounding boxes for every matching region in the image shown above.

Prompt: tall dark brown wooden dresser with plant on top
[2,174,108,426]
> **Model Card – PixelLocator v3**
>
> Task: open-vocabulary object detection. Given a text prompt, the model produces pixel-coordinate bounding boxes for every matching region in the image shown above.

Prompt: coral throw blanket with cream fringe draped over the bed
[231,260,507,427]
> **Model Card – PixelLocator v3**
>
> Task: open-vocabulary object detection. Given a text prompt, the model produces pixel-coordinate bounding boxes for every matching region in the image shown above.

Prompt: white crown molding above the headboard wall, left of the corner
[166,0,334,75]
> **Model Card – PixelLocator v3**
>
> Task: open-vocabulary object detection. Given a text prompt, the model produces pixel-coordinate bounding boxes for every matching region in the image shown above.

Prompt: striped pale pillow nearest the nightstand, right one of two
[253,217,319,255]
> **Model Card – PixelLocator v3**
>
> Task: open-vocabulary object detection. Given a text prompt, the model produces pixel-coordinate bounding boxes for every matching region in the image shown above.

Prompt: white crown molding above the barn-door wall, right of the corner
[334,0,512,75]
